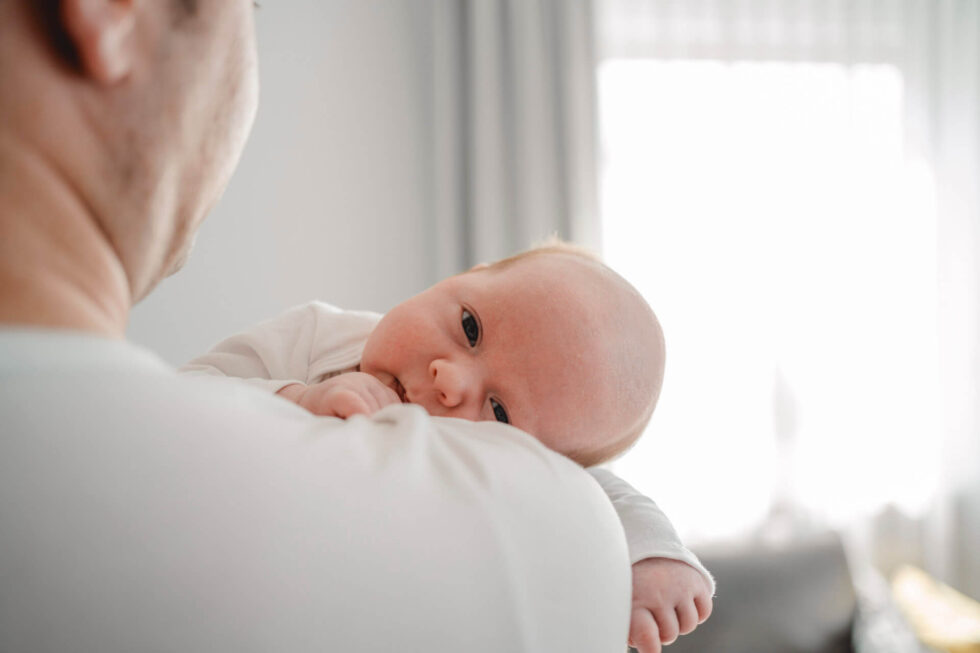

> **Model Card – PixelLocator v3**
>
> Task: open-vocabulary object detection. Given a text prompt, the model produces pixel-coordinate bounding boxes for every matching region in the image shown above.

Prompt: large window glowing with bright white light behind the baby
[599,60,940,541]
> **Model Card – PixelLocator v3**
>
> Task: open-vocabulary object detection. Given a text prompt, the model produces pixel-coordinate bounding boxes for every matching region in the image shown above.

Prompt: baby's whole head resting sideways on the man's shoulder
[361,244,664,466]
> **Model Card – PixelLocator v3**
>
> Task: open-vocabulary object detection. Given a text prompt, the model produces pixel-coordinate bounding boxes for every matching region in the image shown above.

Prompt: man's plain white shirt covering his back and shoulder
[0,330,630,653]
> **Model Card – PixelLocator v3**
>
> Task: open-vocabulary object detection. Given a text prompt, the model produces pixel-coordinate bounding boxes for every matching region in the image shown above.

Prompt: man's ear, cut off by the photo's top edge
[61,0,136,85]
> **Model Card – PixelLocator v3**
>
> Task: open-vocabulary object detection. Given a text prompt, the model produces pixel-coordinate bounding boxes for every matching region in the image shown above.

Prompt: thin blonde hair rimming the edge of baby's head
[478,235,663,467]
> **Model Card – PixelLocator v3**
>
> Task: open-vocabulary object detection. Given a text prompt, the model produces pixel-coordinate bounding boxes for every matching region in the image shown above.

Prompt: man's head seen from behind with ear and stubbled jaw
[0,0,258,301]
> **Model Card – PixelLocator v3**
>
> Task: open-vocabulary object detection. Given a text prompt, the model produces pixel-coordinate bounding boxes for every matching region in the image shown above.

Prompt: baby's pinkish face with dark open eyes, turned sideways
[361,252,616,453]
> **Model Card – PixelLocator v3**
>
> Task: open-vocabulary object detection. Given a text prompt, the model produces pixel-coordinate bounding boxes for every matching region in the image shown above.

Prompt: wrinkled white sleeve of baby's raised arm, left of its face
[178,302,380,393]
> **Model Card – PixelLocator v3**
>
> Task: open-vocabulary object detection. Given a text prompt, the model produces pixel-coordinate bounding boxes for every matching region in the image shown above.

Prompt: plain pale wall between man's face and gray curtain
[129,0,433,364]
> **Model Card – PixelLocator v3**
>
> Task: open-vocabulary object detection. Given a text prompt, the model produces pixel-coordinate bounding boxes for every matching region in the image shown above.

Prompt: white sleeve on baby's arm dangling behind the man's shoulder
[588,467,715,595]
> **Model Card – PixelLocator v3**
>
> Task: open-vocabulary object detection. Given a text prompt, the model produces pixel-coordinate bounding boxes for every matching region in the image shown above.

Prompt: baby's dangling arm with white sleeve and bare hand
[588,467,715,653]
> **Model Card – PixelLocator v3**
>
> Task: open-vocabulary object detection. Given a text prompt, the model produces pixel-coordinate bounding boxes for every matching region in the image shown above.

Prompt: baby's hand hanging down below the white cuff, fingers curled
[629,558,711,653]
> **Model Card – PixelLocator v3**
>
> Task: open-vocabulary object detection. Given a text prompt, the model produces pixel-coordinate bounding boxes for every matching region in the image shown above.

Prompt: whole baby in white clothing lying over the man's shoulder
[182,243,713,650]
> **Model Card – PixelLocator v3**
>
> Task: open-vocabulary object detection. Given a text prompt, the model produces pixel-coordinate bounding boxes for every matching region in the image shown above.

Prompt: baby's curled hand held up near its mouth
[276,372,401,419]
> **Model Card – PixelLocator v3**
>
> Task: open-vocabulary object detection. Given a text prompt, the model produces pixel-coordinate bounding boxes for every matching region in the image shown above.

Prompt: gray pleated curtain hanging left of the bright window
[416,0,600,280]
